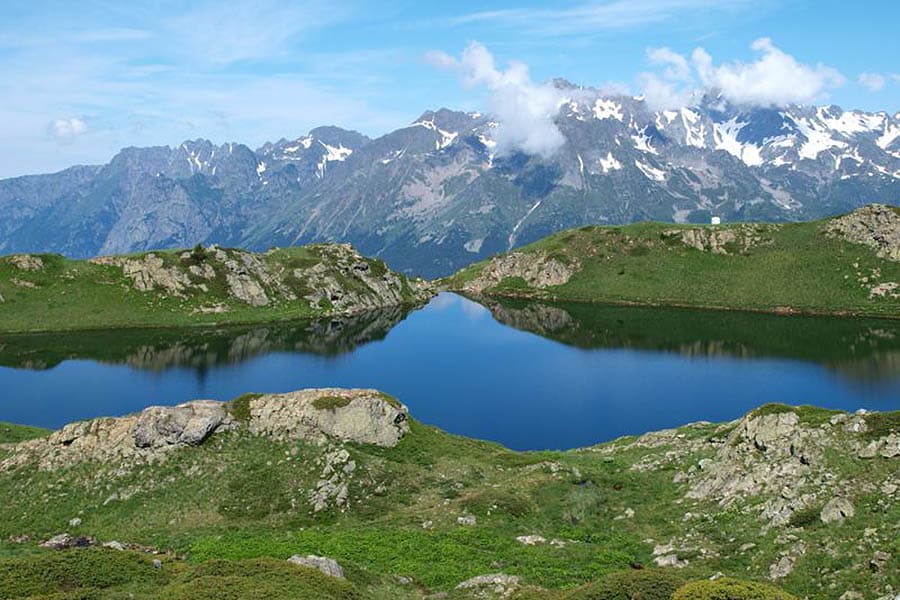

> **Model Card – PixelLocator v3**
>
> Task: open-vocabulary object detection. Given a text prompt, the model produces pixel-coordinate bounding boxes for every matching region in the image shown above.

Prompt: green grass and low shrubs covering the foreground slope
[0,395,900,600]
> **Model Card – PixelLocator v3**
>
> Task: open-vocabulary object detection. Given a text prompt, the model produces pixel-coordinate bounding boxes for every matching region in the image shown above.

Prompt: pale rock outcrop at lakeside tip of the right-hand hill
[462,252,581,293]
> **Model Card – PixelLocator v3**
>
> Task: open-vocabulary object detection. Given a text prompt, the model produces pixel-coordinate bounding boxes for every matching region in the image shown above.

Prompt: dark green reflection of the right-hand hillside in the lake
[486,298,900,379]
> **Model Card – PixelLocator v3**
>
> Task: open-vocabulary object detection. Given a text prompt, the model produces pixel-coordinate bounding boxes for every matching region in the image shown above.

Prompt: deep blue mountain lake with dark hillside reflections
[0,294,900,449]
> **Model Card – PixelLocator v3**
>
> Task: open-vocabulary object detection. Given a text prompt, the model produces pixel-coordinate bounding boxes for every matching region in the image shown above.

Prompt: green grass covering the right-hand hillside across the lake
[446,214,900,318]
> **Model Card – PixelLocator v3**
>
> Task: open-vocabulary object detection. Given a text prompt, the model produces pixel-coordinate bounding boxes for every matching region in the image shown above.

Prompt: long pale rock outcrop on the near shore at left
[0,388,409,474]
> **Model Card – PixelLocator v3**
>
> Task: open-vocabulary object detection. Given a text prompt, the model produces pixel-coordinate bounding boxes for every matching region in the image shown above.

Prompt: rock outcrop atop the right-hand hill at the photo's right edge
[824,204,900,261]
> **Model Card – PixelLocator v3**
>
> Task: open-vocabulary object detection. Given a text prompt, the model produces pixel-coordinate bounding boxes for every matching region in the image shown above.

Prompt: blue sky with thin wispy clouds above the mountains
[0,0,900,177]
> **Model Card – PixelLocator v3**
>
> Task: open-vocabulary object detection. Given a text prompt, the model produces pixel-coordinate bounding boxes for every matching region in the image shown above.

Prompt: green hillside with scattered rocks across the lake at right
[446,204,900,317]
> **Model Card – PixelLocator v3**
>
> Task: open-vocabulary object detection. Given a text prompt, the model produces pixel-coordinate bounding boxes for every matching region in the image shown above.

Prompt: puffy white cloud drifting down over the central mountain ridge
[425,42,565,157]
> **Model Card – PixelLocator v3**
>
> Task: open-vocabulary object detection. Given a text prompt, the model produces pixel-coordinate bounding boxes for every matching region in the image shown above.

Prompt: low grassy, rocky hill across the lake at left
[0,244,432,331]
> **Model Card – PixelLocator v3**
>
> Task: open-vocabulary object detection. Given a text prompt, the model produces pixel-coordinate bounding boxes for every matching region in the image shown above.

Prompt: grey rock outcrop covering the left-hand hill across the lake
[91,244,434,313]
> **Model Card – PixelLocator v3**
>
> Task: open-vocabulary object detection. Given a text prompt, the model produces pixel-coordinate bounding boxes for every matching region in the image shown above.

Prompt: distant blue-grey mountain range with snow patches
[0,80,900,277]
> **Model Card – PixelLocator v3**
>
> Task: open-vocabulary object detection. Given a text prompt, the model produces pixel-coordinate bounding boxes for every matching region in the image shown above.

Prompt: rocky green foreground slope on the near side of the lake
[0,389,900,600]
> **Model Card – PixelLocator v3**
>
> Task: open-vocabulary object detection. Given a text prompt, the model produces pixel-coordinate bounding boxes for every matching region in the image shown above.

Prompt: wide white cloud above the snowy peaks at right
[639,38,844,108]
